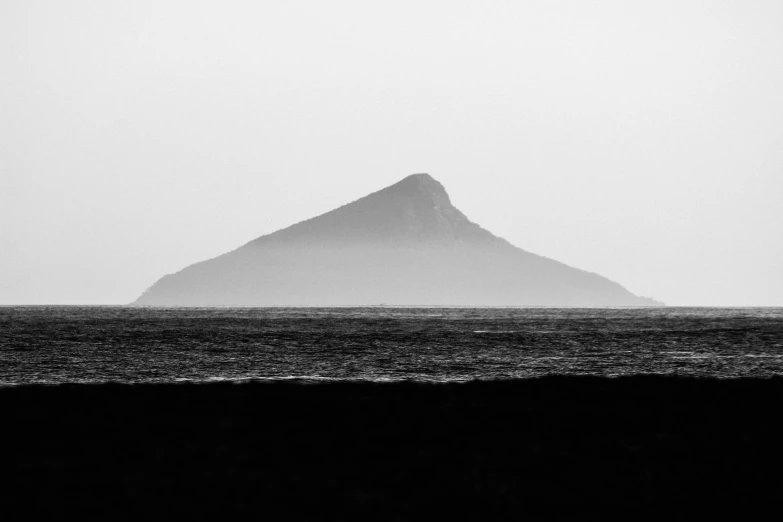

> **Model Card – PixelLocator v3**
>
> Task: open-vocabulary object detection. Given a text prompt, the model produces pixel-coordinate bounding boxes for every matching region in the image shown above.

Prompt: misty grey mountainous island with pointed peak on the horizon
[133,174,662,307]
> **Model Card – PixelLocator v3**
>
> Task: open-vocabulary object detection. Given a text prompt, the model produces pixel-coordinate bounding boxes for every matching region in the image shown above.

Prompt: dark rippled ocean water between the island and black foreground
[0,307,783,385]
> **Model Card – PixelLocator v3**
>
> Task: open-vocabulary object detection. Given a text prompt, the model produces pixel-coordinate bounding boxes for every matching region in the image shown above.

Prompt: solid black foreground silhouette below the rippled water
[0,377,783,520]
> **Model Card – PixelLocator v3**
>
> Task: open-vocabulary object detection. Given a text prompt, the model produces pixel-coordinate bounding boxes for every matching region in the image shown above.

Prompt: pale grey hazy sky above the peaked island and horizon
[0,0,783,305]
